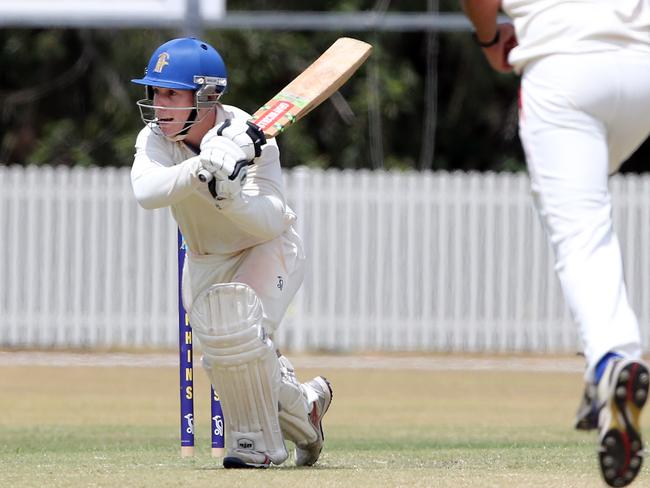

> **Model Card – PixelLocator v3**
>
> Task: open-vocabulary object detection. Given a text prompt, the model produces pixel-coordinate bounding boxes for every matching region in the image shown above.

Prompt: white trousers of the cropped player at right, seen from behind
[519,50,650,381]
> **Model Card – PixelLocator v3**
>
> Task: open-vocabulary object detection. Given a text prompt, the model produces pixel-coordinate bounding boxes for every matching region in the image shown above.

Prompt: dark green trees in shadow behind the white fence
[0,0,650,171]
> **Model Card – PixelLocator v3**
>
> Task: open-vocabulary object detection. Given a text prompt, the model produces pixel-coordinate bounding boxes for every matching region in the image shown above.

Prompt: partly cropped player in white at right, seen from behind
[462,0,650,486]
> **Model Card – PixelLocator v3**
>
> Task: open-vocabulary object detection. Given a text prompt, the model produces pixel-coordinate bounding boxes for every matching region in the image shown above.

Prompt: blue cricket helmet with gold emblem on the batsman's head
[131,37,228,95]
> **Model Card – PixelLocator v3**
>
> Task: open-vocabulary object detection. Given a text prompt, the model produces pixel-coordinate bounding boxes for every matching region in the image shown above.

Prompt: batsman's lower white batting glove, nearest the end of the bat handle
[198,135,253,201]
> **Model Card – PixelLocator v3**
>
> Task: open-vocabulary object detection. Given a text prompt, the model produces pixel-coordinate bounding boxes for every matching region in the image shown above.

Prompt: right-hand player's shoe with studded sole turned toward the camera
[597,358,650,486]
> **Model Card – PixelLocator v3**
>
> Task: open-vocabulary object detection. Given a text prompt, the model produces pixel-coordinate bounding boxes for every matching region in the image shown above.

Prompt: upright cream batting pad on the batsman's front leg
[190,283,288,464]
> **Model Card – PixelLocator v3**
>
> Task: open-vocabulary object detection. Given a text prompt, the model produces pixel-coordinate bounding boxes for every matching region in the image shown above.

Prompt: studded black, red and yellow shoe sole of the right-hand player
[598,361,650,487]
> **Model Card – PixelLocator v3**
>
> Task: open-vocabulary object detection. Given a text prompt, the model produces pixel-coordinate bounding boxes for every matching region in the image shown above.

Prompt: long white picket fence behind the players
[0,166,650,352]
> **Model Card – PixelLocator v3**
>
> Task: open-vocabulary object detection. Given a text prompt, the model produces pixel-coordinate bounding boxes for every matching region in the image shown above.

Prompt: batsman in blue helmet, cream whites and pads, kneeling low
[131,38,332,468]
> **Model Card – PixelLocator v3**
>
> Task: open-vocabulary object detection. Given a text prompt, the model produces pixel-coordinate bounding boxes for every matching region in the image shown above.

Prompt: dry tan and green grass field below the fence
[0,358,636,488]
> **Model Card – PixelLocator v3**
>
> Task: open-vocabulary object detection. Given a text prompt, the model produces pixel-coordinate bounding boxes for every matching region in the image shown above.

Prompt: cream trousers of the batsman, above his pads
[182,228,305,334]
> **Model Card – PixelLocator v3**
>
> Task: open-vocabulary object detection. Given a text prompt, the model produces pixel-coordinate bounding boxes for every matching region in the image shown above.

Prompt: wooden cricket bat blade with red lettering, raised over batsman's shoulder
[251,37,372,137]
